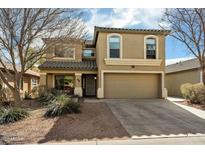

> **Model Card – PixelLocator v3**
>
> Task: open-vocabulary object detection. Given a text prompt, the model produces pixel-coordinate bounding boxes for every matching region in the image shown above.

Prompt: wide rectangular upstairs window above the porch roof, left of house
[55,48,75,59]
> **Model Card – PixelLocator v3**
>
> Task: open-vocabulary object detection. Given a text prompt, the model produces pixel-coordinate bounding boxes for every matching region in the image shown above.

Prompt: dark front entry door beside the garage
[84,75,96,96]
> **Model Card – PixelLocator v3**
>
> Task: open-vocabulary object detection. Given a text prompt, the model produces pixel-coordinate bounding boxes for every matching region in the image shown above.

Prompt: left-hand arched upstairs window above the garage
[108,34,122,58]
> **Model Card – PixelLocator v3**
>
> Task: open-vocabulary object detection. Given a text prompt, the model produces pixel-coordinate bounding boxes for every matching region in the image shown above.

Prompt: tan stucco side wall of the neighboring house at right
[165,69,200,97]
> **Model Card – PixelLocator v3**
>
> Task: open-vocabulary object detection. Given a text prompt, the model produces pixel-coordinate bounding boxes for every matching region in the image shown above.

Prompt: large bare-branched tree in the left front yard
[0,9,87,105]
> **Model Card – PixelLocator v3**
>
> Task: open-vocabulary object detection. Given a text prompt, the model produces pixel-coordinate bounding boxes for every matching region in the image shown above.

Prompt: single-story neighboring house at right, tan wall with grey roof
[165,58,202,97]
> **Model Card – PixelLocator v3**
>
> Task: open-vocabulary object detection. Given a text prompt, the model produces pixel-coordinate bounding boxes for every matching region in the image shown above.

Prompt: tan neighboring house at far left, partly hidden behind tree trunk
[0,64,40,96]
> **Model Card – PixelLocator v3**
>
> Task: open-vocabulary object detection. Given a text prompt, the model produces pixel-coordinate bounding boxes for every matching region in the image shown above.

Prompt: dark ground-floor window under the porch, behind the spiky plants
[55,75,74,94]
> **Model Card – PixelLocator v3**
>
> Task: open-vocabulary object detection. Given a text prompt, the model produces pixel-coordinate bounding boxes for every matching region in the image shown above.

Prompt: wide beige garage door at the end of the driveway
[104,73,161,98]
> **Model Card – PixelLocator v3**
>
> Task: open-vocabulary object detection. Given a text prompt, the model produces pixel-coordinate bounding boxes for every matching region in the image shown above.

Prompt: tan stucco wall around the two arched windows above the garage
[96,32,165,87]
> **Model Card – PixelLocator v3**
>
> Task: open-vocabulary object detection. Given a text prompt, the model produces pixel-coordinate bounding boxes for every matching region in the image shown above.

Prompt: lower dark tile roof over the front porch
[39,60,97,70]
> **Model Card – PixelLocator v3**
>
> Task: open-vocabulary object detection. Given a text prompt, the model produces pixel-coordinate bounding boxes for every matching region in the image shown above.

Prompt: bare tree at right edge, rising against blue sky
[161,8,205,84]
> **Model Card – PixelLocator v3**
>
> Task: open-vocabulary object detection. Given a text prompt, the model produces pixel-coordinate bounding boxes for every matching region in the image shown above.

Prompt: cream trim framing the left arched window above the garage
[107,33,123,59]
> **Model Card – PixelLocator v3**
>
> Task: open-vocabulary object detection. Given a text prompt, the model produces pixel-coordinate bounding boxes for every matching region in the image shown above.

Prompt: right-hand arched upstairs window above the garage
[145,36,158,59]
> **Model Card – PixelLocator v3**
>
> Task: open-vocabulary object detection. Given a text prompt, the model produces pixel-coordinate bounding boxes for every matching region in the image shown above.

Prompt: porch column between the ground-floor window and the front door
[74,73,83,97]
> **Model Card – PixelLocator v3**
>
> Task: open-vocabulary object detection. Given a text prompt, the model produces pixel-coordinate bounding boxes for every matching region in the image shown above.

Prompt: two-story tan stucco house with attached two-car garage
[39,27,170,98]
